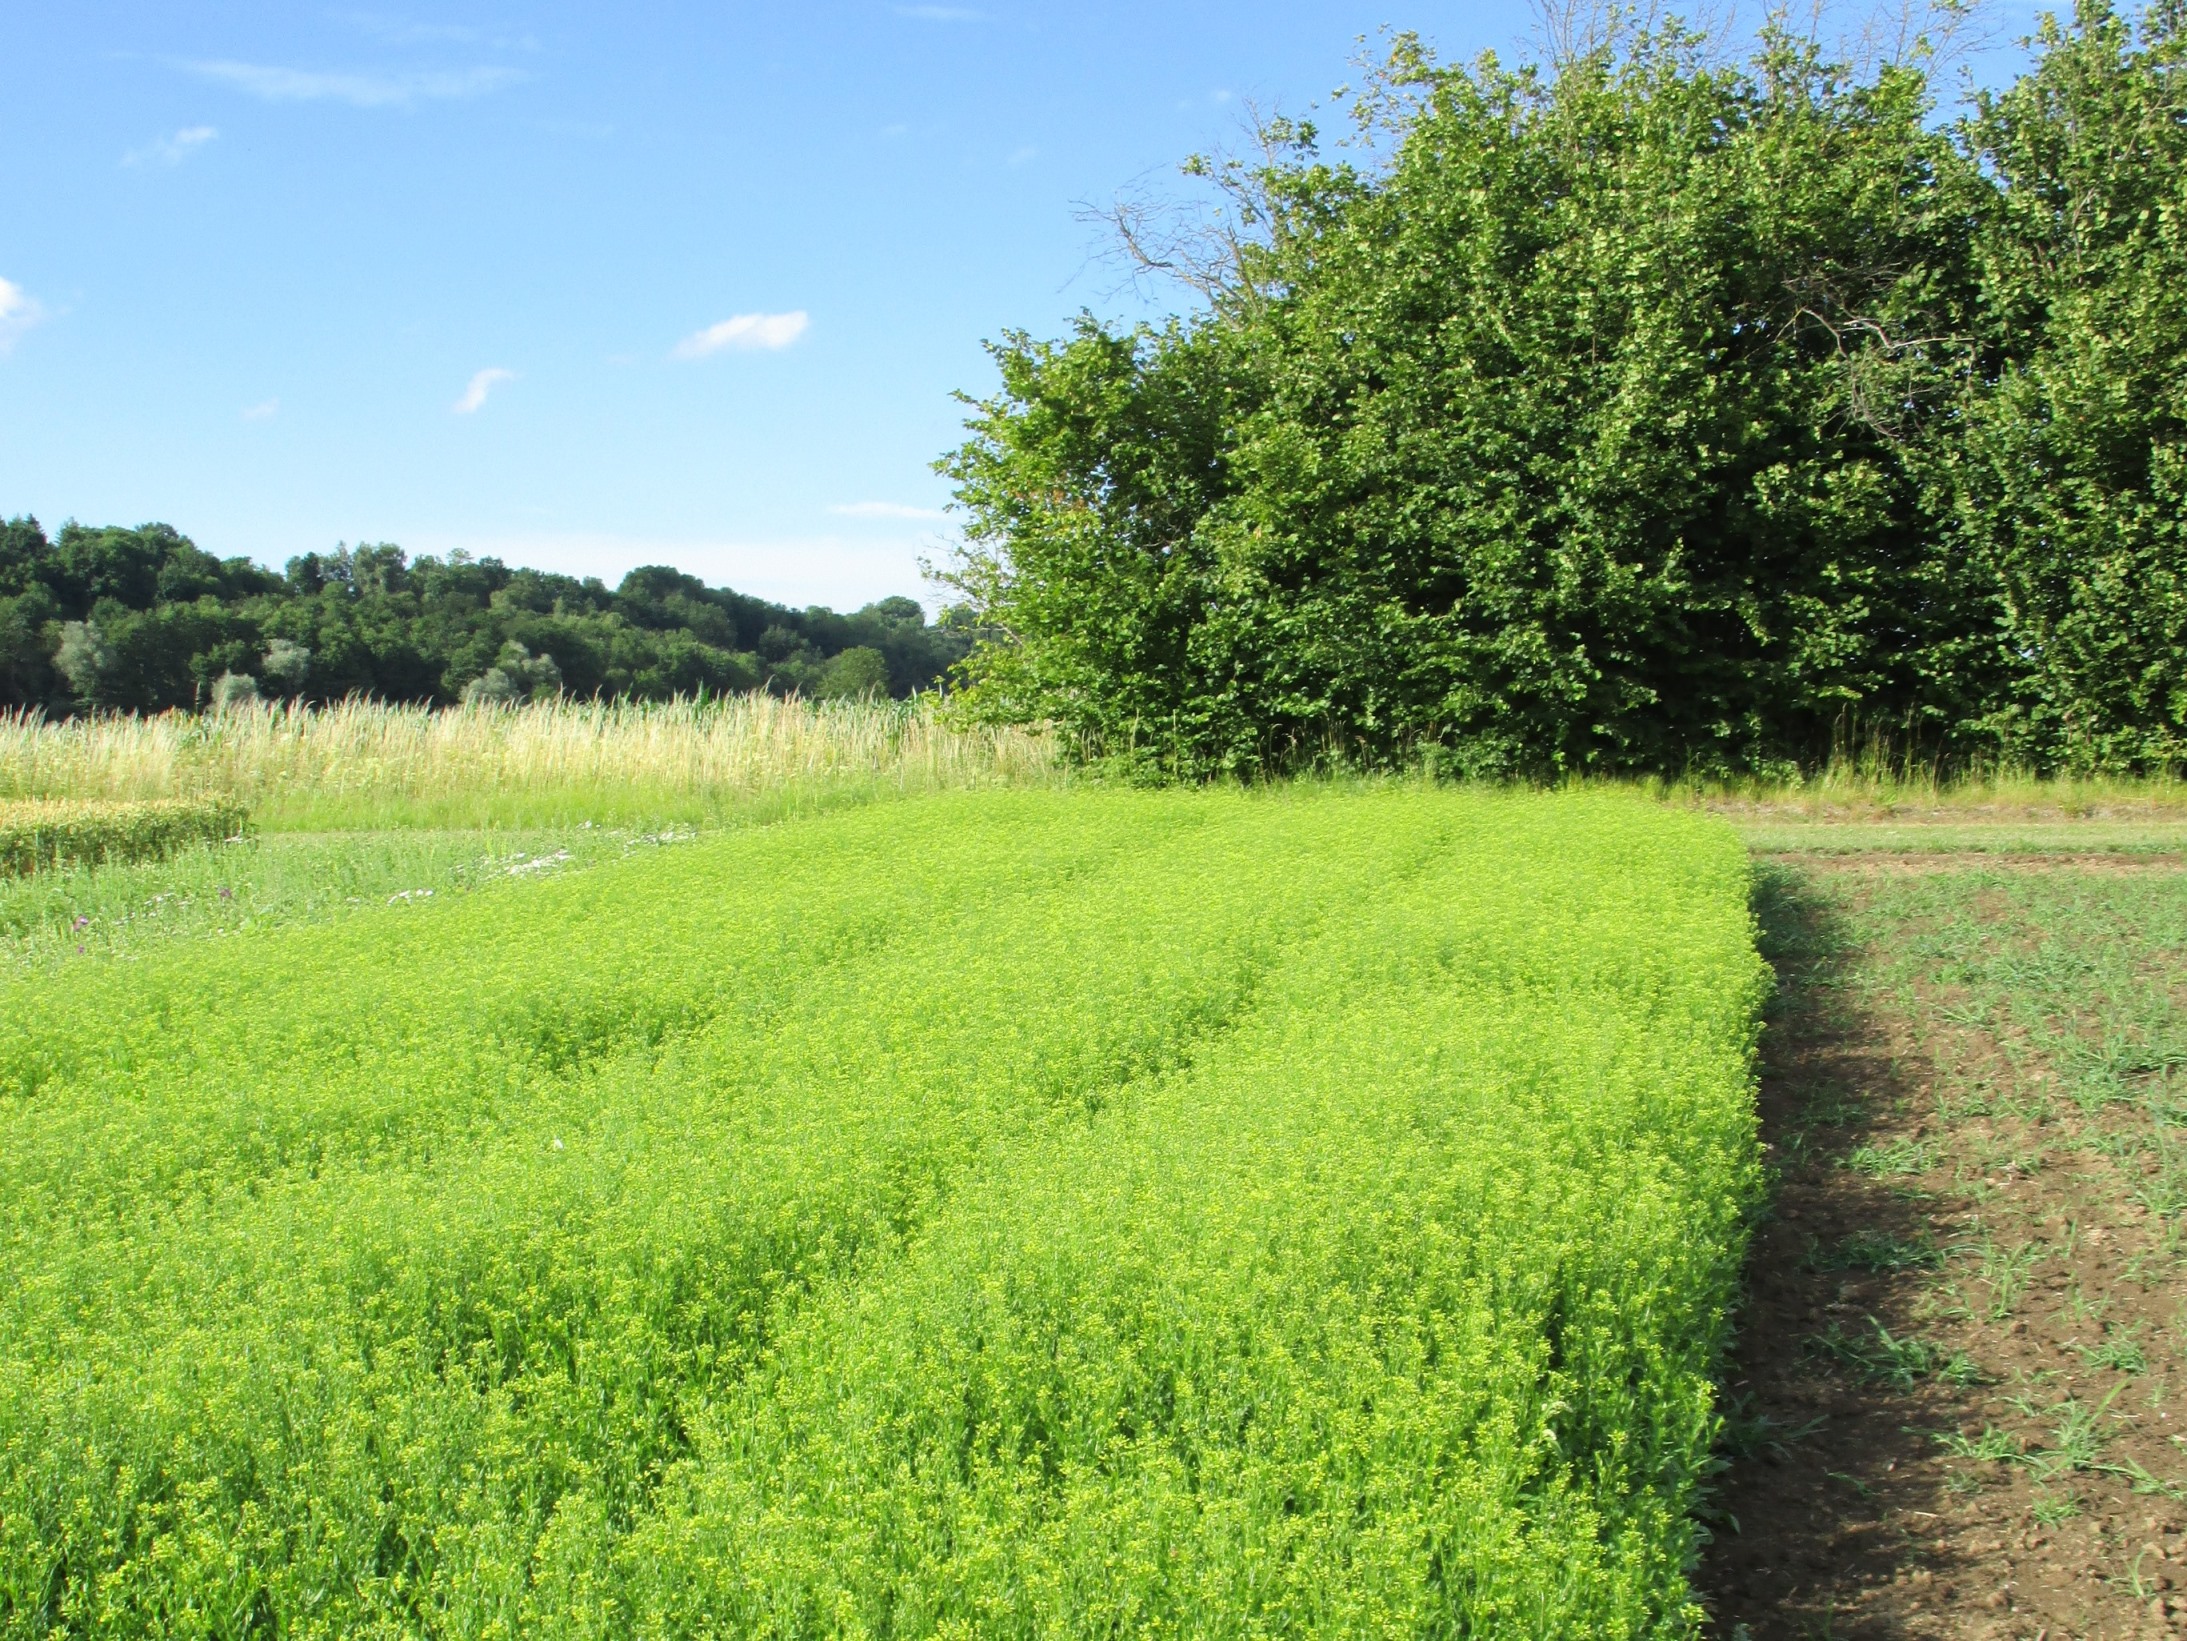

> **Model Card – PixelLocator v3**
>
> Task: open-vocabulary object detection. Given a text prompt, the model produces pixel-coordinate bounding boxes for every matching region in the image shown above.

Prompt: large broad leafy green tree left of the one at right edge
[947,31,1968,775]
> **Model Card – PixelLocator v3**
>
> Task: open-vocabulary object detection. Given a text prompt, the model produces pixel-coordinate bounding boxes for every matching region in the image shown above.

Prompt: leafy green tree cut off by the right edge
[1940,4,2187,768]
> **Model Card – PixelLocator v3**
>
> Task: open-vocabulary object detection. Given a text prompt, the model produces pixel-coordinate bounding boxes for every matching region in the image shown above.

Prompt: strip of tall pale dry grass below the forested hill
[0,696,1061,827]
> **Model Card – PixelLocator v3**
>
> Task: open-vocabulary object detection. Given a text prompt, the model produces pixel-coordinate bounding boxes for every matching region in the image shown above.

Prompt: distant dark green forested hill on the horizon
[0,519,971,713]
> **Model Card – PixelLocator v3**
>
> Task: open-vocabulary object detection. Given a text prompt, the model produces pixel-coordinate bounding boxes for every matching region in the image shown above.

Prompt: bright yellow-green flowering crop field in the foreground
[0,788,1765,1637]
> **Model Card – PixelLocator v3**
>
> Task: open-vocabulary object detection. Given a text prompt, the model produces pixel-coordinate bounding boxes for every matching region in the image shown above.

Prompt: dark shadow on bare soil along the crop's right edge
[1699,864,1935,1637]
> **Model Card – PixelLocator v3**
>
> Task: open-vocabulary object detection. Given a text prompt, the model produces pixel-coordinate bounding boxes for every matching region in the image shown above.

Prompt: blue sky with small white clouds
[0,0,2029,606]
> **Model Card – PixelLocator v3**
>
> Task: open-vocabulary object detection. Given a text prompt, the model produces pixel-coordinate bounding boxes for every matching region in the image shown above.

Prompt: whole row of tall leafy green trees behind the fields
[940,0,2187,777]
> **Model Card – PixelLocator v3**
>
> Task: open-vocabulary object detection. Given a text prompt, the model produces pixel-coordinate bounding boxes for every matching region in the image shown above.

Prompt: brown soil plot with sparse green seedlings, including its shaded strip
[1697,856,2187,1641]
